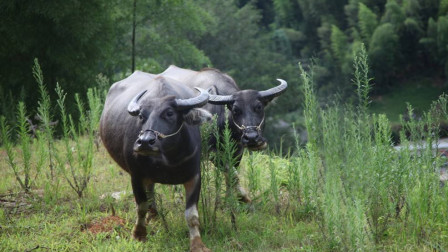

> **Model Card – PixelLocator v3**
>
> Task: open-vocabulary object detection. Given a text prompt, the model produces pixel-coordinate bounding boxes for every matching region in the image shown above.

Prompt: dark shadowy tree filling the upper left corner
[0,0,122,106]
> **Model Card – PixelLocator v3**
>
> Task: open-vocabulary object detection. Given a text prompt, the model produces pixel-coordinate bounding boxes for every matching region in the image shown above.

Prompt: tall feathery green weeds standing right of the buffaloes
[288,43,448,251]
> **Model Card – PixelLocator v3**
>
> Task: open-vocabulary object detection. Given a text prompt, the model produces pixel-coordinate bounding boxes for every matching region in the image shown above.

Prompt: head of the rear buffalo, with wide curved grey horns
[209,79,288,150]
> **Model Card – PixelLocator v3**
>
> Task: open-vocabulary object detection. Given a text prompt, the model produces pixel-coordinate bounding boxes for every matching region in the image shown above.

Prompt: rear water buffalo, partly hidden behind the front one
[158,66,288,202]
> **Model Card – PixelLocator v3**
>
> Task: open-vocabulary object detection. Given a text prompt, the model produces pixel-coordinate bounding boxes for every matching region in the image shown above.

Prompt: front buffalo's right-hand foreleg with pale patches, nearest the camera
[184,174,210,252]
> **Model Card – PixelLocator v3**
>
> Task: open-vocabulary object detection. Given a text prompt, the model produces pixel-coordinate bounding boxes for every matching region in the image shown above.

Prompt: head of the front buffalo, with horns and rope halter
[128,88,211,156]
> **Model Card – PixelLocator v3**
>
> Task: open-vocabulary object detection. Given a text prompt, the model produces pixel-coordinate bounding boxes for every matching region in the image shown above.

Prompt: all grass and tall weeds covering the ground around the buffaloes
[0,48,448,251]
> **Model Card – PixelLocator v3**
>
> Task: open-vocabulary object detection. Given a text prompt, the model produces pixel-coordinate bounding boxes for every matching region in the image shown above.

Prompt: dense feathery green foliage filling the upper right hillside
[274,0,448,92]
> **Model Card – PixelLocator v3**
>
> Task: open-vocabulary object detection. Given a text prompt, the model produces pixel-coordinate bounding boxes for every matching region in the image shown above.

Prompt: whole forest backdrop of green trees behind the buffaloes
[0,0,448,150]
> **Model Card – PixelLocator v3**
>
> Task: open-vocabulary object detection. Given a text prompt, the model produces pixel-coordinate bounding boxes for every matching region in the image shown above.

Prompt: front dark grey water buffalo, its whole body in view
[100,72,211,251]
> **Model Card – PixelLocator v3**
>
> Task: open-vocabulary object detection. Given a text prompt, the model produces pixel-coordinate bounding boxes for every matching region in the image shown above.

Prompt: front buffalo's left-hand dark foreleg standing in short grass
[131,178,149,241]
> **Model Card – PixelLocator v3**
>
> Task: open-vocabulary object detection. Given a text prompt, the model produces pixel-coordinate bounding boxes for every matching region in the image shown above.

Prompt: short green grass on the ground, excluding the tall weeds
[0,143,448,251]
